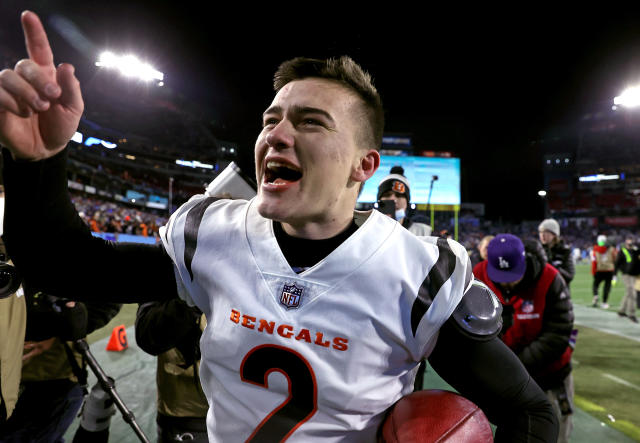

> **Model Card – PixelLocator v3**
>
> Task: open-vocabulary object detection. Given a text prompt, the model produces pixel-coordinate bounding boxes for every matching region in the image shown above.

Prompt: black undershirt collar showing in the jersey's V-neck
[273,220,358,274]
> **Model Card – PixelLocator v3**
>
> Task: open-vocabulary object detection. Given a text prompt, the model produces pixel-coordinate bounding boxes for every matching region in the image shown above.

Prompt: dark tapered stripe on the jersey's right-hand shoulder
[411,238,458,337]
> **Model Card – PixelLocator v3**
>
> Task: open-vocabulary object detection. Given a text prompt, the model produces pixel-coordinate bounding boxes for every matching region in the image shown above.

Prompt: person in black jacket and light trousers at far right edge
[614,234,640,323]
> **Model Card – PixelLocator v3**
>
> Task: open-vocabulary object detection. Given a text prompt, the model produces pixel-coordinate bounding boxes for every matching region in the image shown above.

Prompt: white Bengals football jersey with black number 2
[161,196,473,442]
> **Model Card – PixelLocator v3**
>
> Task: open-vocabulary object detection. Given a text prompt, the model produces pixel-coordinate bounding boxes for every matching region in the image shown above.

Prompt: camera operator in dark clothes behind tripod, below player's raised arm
[0,282,121,442]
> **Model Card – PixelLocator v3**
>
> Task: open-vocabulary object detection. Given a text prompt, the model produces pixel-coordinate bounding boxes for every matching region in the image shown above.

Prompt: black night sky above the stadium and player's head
[0,0,640,220]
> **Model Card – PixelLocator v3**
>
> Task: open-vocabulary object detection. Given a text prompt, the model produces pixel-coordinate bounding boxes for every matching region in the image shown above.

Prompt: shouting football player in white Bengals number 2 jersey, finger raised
[0,12,557,442]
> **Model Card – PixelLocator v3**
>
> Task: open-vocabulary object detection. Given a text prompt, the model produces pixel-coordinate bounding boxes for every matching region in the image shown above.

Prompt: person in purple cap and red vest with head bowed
[473,234,574,442]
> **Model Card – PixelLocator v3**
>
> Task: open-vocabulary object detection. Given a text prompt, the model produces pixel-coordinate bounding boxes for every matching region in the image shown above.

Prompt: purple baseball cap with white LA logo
[487,234,527,283]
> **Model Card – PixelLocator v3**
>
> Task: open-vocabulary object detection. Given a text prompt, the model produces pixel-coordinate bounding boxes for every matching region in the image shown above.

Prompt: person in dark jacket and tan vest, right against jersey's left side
[135,299,208,443]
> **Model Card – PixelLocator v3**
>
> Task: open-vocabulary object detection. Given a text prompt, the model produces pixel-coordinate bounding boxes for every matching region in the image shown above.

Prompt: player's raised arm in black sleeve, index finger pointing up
[0,12,177,303]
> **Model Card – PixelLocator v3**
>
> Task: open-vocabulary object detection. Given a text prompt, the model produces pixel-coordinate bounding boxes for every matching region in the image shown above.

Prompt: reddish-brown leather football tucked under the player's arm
[382,389,493,443]
